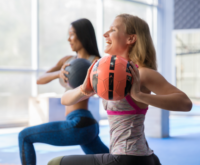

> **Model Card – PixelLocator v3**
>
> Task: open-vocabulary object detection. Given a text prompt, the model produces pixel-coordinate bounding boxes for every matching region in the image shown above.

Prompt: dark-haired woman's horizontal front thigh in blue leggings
[19,118,98,146]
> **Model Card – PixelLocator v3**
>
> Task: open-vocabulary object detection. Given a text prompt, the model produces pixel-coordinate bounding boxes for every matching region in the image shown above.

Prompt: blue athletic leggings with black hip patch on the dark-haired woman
[19,109,109,165]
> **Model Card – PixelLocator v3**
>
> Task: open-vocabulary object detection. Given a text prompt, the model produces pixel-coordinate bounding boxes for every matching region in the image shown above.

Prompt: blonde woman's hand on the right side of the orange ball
[129,61,140,101]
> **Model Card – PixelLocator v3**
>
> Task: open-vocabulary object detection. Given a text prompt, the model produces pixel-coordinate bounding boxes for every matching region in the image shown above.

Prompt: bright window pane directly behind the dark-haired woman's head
[39,0,97,69]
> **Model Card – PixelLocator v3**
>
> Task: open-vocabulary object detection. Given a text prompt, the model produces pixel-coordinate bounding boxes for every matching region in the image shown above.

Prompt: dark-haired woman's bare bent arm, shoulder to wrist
[37,56,71,84]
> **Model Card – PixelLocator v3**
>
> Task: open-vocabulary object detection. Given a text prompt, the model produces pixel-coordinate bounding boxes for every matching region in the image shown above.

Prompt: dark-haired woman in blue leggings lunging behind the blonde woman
[19,19,109,165]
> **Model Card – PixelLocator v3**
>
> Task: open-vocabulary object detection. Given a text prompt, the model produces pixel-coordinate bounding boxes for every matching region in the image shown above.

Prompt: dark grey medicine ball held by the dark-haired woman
[65,58,91,88]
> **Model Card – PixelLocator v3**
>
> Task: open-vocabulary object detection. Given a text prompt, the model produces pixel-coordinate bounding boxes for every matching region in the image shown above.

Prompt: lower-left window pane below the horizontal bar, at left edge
[0,72,32,123]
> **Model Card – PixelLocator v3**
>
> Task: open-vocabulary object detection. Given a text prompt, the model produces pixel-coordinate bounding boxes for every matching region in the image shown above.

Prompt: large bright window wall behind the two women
[0,0,157,127]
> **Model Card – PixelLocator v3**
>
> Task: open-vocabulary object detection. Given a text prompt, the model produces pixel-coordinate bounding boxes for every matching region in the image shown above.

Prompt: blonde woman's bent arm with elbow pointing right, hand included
[130,62,192,111]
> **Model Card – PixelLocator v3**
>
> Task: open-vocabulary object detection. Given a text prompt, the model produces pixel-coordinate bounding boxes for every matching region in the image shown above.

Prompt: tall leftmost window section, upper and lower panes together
[0,0,32,124]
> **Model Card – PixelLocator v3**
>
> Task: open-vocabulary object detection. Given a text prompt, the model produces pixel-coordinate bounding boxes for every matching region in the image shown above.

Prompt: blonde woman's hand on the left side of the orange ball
[82,60,97,95]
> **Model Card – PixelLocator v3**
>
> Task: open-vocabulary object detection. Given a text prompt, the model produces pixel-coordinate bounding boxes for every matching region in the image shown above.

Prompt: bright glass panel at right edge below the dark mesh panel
[175,32,200,99]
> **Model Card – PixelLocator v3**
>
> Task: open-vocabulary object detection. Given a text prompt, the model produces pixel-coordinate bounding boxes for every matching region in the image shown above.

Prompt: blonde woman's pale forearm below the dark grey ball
[61,87,92,106]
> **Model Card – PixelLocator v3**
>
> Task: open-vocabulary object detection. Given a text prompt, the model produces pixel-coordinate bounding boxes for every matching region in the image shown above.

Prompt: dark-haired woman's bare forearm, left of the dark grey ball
[37,71,60,84]
